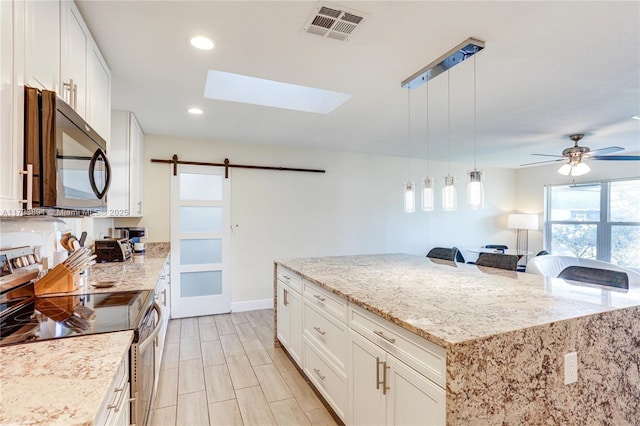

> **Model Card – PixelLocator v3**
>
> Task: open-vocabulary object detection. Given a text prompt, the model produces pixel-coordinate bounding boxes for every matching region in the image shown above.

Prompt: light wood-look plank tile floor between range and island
[149,309,336,426]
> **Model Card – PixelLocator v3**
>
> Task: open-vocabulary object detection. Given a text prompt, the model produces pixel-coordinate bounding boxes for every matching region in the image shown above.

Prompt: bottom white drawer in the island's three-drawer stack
[304,337,347,421]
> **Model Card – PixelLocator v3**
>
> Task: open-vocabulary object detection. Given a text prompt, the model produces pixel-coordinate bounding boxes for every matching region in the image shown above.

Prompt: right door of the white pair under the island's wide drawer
[386,355,446,426]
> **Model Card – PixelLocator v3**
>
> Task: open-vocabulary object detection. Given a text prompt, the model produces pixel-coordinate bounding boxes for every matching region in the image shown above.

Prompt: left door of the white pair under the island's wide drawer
[347,330,386,426]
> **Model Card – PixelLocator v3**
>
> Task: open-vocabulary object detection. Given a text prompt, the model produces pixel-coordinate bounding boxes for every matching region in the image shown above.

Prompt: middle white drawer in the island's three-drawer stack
[304,300,347,371]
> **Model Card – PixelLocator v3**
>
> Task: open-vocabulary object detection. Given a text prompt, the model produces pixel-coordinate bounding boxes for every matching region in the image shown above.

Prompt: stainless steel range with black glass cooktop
[0,247,162,426]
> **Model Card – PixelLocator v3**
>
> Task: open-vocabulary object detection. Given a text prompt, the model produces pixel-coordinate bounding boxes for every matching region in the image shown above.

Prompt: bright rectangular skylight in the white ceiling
[204,70,351,114]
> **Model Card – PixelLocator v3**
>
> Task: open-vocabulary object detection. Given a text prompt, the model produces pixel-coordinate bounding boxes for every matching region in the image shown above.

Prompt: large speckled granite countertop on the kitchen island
[276,254,640,348]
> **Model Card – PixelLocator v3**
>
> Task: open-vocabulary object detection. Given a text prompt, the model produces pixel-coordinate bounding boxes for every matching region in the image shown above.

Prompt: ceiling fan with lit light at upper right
[521,133,640,176]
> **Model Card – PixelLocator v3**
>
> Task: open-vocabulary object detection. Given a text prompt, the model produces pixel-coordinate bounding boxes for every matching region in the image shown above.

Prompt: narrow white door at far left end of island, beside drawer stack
[277,281,302,367]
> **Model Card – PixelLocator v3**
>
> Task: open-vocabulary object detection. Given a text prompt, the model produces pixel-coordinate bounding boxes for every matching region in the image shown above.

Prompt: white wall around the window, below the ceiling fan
[515,161,640,252]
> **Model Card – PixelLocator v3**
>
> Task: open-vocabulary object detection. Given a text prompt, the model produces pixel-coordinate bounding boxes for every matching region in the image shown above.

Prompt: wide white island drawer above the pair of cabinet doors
[349,305,447,388]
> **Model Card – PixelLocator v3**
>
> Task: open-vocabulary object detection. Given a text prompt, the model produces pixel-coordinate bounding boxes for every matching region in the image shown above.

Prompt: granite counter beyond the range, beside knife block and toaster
[70,243,169,294]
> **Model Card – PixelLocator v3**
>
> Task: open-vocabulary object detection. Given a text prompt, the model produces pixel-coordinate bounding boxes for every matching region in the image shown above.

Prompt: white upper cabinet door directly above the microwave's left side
[24,0,60,92]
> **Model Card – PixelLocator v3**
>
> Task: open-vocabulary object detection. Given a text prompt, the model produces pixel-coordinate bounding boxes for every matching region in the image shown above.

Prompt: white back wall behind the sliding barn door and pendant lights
[115,135,515,302]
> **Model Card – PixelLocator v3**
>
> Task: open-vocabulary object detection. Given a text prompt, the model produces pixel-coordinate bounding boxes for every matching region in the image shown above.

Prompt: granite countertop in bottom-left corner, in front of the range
[0,331,133,425]
